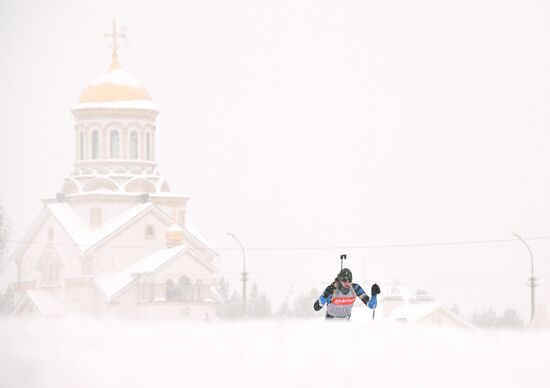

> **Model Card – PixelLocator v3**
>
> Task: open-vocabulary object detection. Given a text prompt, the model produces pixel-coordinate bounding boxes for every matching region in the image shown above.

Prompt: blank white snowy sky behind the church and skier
[0,0,550,318]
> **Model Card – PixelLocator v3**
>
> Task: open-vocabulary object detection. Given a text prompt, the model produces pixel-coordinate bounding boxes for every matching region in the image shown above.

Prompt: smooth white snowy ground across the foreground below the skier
[0,320,550,388]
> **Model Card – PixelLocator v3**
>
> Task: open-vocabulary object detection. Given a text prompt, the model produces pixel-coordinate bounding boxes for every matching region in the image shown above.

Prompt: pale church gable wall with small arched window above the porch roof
[93,213,171,273]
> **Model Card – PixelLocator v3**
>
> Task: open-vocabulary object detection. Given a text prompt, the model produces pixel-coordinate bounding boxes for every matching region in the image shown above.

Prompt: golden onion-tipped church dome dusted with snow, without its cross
[78,55,151,104]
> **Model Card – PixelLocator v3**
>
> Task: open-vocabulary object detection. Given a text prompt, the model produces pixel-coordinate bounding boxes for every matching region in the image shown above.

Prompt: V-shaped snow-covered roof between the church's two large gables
[46,202,152,252]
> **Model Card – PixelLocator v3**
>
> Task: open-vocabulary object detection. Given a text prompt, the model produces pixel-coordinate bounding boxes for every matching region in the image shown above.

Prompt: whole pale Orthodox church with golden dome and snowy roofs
[8,31,219,320]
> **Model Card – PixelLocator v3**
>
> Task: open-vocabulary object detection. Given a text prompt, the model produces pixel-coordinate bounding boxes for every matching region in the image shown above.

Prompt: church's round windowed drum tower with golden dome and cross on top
[62,22,169,194]
